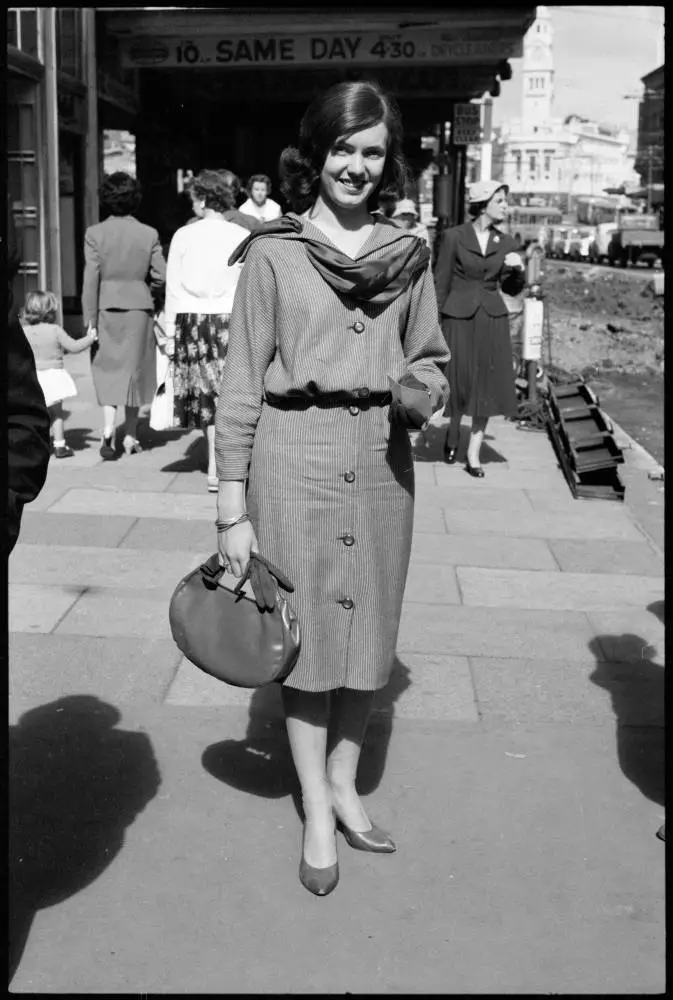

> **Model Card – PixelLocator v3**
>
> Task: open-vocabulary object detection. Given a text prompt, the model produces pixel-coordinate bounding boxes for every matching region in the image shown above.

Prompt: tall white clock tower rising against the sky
[522,7,554,133]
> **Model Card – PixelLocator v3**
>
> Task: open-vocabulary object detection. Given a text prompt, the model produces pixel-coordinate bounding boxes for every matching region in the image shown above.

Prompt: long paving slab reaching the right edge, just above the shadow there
[456,566,664,611]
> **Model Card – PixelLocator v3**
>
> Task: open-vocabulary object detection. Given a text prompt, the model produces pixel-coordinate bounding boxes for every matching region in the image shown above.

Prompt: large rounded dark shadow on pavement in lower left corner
[9,695,161,981]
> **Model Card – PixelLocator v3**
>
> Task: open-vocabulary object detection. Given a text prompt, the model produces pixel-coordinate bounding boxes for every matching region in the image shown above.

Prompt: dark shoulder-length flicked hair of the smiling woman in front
[279,80,407,214]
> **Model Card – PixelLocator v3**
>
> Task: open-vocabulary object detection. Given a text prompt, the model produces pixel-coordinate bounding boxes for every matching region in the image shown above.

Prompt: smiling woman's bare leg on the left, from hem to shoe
[282,686,337,868]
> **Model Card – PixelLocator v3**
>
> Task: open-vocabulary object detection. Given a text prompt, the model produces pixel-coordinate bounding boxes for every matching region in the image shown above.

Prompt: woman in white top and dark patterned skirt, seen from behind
[165,170,249,493]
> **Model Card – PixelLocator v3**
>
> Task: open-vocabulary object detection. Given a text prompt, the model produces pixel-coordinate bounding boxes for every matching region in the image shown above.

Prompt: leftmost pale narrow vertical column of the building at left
[40,7,63,323]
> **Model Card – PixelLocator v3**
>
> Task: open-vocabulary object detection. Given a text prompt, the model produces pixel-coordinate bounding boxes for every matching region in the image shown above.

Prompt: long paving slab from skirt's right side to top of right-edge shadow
[397,604,594,660]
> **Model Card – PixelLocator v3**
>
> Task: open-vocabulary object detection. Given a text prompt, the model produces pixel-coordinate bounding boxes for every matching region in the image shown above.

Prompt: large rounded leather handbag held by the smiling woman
[169,553,301,688]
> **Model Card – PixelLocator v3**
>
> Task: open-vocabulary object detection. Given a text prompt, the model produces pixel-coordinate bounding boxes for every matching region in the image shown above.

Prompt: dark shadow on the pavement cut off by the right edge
[589,601,665,806]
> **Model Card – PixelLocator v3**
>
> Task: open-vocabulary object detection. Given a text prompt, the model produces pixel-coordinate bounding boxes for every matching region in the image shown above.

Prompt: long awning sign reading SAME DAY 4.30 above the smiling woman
[122,30,520,69]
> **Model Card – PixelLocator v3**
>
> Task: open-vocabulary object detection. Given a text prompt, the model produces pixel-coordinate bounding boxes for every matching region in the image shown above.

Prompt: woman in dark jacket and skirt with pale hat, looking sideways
[435,181,525,479]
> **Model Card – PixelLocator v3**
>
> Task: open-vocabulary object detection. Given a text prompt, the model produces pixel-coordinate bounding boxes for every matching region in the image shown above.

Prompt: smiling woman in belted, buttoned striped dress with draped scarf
[216,82,449,895]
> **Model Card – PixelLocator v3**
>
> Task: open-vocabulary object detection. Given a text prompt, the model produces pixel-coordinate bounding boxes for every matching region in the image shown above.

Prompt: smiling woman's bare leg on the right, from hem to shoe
[327,688,374,833]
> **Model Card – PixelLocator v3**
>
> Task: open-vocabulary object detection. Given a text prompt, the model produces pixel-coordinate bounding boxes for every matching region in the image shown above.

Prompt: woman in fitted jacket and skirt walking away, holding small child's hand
[82,171,166,460]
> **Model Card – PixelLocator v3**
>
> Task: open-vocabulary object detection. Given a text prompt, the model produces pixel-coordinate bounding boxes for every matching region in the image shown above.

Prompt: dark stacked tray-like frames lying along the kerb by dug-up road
[547,381,624,500]
